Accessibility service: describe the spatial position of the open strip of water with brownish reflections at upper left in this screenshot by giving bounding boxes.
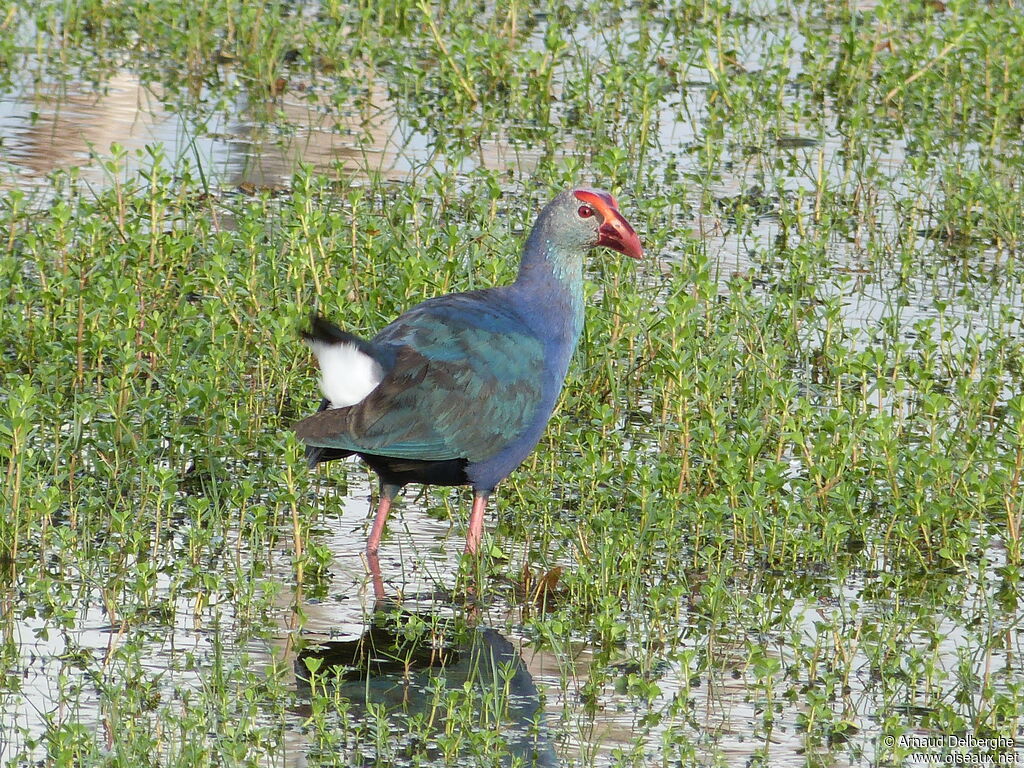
[0,71,430,195]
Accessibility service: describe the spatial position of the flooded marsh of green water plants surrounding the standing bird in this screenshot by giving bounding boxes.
[0,0,1024,766]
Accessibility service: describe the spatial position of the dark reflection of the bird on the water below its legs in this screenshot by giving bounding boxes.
[294,601,560,768]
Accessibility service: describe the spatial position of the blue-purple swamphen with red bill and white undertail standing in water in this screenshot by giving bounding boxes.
[295,188,643,588]
